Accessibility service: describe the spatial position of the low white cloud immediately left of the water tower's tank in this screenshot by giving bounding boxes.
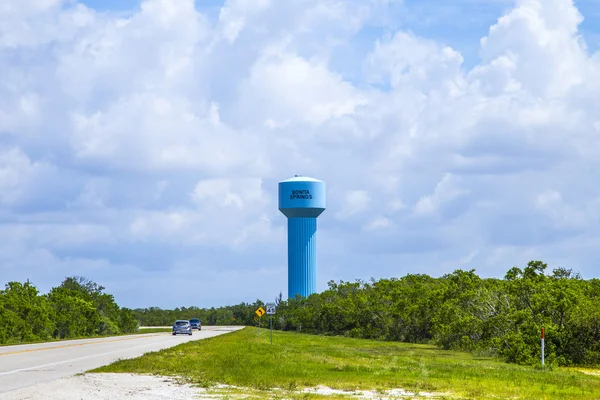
[128,178,284,251]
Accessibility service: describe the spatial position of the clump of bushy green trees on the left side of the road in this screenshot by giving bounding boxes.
[0,277,138,344]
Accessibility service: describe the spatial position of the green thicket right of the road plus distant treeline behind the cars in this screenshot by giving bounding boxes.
[134,261,600,366]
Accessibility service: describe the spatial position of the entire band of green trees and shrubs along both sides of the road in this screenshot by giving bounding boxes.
[5,261,600,367]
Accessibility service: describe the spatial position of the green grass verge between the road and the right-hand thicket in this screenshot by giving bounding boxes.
[91,328,600,399]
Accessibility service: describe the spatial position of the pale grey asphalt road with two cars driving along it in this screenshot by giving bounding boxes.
[0,326,242,398]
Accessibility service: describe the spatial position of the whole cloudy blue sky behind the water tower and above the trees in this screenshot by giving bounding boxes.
[0,0,600,308]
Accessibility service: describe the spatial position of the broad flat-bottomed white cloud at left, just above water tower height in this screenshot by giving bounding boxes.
[71,94,267,173]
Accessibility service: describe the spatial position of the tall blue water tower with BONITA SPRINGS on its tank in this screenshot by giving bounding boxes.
[279,175,325,298]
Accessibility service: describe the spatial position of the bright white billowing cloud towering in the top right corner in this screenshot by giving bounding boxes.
[481,0,587,97]
